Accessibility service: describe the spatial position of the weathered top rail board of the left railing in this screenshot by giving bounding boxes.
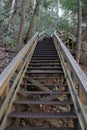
[0,33,38,96]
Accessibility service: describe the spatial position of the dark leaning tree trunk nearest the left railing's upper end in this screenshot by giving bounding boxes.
[24,0,40,43]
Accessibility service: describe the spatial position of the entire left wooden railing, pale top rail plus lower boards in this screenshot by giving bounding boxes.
[0,33,47,124]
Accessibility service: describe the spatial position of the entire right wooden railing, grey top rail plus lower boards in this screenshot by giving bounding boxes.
[53,33,87,130]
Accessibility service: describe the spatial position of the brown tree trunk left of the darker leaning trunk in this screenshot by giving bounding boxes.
[16,0,27,54]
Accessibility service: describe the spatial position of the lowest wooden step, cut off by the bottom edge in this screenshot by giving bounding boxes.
[5,126,79,130]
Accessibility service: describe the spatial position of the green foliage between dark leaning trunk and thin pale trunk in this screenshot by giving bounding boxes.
[37,0,56,34]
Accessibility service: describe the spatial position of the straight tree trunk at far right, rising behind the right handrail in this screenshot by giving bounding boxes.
[76,0,82,63]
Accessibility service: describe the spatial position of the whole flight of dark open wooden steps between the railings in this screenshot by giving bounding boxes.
[5,38,80,130]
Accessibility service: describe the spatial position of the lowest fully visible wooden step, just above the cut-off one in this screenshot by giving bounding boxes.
[8,112,77,119]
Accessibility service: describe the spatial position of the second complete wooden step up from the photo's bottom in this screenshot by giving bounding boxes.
[14,100,73,106]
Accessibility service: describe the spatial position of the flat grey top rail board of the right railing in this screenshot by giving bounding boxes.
[54,33,87,98]
